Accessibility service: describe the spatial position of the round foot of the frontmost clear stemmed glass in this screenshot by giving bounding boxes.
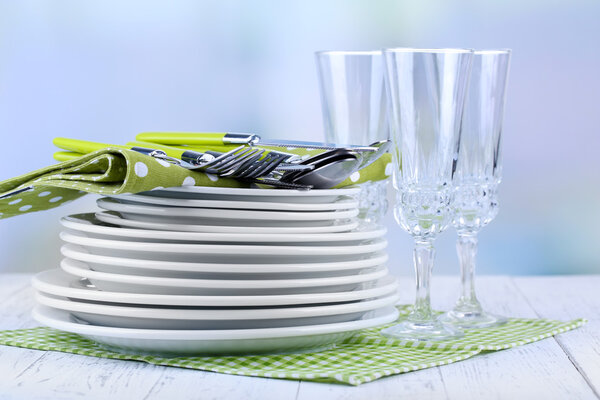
[381,320,463,341]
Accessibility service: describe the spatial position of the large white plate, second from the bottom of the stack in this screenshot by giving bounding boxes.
[36,292,398,329]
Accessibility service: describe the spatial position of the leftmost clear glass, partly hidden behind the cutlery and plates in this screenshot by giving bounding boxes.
[315,51,389,223]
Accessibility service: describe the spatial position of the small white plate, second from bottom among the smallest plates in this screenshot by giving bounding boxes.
[96,197,358,226]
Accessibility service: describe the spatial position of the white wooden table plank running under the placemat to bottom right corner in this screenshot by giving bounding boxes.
[439,277,596,400]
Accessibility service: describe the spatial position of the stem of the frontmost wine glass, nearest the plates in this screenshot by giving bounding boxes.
[408,239,435,321]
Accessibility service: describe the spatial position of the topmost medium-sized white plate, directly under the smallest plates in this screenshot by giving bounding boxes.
[60,213,386,246]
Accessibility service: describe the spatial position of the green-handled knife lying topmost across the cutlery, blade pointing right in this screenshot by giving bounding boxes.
[135,132,377,152]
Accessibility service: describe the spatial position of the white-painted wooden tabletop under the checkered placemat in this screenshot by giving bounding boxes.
[0,274,600,400]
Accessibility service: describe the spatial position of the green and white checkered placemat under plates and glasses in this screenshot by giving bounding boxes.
[0,306,587,385]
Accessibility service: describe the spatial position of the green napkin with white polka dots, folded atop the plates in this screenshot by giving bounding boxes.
[0,148,391,219]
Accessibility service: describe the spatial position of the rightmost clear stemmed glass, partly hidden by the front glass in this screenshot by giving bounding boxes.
[441,50,510,329]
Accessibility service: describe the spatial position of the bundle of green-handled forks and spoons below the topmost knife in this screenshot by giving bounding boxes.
[54,138,390,189]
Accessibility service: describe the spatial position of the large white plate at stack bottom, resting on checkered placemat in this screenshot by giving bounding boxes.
[33,306,398,355]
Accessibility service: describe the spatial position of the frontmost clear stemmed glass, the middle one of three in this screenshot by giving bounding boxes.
[382,49,472,340]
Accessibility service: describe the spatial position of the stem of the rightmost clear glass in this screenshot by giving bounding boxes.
[454,232,481,312]
